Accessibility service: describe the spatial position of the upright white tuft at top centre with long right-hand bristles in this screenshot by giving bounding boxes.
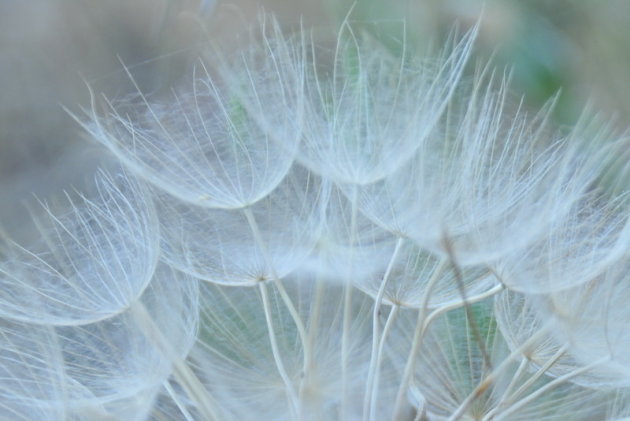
[298,21,477,185]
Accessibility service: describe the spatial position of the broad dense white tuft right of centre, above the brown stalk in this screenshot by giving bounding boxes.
[354,75,599,265]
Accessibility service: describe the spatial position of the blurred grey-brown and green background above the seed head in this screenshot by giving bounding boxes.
[0,0,630,226]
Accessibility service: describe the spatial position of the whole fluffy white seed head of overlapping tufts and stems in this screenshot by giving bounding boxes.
[0,13,630,421]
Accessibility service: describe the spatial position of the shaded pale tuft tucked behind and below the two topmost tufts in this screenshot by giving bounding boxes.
[156,166,329,286]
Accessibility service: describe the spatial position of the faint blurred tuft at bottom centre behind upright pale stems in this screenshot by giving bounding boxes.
[191,279,402,421]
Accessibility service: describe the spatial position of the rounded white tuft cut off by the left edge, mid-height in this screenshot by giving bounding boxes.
[0,172,159,325]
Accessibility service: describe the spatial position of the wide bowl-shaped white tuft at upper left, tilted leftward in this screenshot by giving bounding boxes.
[82,17,303,209]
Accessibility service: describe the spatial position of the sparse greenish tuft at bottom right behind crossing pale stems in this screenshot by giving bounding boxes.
[392,300,612,420]
